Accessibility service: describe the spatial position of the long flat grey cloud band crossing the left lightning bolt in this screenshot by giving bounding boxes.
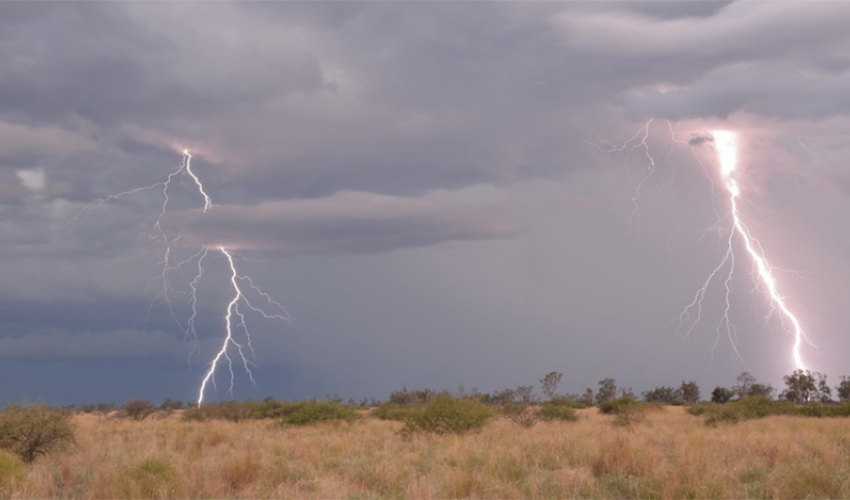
[181,192,520,255]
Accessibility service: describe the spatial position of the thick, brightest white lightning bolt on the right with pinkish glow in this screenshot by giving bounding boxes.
[679,130,811,370]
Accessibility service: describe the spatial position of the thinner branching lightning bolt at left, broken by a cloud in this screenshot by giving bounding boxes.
[71,150,289,406]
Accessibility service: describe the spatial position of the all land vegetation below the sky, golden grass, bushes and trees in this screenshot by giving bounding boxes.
[0,371,850,499]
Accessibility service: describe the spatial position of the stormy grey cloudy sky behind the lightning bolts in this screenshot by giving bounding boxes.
[0,0,850,404]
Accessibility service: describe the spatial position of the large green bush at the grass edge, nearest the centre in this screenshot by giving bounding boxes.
[402,395,493,434]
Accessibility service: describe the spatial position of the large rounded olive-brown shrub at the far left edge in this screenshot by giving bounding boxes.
[0,403,74,463]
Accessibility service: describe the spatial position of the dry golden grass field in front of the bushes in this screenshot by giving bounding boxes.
[0,407,850,499]
